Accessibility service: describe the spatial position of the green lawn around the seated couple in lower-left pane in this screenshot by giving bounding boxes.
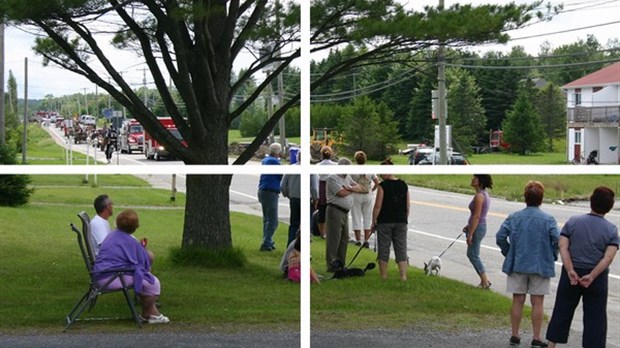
[0,175,300,333]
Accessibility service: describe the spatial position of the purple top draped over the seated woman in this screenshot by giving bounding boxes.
[94,230,155,293]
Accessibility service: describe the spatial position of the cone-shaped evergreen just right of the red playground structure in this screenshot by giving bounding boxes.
[502,79,544,155]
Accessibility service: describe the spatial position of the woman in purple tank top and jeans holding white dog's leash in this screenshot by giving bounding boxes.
[463,174,493,289]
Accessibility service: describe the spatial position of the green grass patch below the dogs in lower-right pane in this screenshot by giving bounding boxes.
[311,238,512,331]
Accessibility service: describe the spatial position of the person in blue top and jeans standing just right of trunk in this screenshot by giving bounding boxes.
[258,143,282,251]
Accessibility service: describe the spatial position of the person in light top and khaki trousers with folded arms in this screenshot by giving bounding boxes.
[325,157,360,272]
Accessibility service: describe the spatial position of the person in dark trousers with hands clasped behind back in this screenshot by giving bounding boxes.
[547,186,620,348]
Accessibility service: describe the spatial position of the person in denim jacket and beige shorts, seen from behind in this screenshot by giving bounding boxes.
[495,181,560,348]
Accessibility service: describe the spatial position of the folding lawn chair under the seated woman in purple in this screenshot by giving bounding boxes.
[64,212,142,331]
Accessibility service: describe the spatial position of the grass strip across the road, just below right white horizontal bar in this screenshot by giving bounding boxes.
[398,175,620,202]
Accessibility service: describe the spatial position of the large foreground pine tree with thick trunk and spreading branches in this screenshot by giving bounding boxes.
[0,0,552,250]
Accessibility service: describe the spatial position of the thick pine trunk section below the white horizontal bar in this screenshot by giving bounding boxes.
[182,175,232,250]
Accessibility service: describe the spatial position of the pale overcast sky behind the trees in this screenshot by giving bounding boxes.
[5,0,620,99]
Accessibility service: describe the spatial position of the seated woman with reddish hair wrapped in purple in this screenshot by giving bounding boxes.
[94,209,170,324]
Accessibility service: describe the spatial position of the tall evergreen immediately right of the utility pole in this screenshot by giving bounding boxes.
[446,69,487,153]
